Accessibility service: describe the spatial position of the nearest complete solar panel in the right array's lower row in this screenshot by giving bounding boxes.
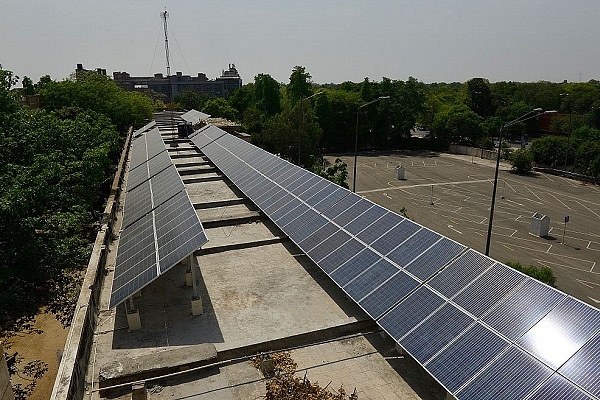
[425,324,509,393]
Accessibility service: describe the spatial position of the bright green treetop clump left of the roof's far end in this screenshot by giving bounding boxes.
[41,72,154,133]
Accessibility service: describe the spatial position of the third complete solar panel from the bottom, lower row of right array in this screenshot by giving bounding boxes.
[378,287,444,341]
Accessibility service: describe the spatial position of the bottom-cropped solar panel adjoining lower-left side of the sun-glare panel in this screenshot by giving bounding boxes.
[457,347,552,400]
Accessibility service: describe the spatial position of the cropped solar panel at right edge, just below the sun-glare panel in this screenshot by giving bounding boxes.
[558,332,600,397]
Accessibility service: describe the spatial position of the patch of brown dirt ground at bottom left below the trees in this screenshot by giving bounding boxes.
[5,312,69,400]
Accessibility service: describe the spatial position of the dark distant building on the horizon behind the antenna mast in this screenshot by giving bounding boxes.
[113,64,242,97]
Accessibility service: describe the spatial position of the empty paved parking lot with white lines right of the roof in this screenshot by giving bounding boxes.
[328,152,600,307]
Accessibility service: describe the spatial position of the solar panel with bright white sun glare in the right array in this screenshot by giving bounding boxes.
[517,297,600,369]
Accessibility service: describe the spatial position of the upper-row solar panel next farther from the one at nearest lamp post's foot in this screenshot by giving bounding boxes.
[404,238,466,281]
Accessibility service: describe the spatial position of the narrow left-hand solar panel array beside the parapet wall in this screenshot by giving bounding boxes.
[110,124,208,308]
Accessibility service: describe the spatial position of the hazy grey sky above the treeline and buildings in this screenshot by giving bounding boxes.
[0,0,600,83]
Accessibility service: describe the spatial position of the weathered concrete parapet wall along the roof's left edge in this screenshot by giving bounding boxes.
[50,129,132,400]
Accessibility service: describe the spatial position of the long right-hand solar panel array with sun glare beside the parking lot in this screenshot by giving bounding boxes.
[191,127,600,400]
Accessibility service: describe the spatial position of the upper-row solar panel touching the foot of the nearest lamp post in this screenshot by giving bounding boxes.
[427,250,494,298]
